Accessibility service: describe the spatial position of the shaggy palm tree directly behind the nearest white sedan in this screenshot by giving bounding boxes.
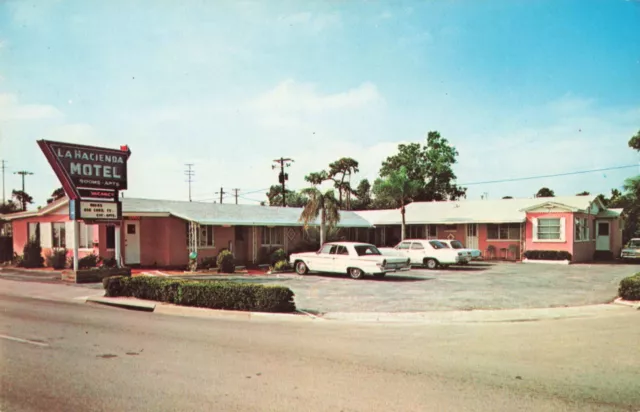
[299,187,340,247]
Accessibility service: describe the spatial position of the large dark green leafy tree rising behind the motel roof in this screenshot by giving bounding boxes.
[380,131,467,201]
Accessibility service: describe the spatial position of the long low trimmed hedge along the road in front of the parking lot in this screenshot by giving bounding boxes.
[102,276,296,313]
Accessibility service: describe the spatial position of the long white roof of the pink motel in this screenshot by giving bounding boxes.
[3,196,622,227]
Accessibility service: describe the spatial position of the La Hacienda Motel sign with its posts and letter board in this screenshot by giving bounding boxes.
[38,140,131,271]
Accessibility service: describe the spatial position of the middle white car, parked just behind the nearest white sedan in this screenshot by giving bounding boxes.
[380,239,470,269]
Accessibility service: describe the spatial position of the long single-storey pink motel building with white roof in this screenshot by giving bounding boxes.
[3,196,623,267]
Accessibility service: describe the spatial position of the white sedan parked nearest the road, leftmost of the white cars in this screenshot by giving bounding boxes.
[289,242,411,279]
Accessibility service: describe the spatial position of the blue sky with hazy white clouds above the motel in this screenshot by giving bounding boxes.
[0,0,640,208]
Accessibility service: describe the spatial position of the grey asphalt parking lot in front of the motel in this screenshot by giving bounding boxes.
[190,263,640,313]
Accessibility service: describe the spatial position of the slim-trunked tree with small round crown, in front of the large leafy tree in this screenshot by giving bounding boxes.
[373,166,422,240]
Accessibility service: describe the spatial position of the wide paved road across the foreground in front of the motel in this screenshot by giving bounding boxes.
[0,294,640,412]
